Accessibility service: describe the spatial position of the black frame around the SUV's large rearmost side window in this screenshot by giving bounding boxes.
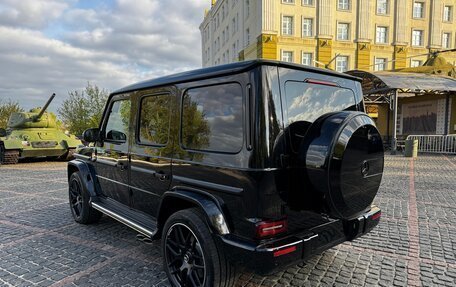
[178,81,247,155]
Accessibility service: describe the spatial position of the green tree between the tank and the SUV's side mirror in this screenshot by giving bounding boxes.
[58,83,109,135]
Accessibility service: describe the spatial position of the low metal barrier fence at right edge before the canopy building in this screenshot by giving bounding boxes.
[407,134,456,154]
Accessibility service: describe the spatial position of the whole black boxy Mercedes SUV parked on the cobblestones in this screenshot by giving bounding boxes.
[68,60,383,286]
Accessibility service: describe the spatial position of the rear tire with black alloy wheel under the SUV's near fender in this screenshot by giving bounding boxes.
[162,208,235,287]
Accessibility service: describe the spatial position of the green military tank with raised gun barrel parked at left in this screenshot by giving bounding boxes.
[0,94,81,164]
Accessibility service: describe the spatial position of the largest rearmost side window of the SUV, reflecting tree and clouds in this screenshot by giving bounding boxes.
[181,83,243,153]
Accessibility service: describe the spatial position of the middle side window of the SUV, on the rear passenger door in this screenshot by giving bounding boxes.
[139,94,171,146]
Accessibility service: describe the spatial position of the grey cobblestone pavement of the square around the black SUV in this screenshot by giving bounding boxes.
[0,156,456,287]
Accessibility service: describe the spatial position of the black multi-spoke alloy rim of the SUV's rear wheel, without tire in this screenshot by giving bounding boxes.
[165,223,206,287]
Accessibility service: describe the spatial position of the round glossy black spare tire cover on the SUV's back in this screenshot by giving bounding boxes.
[299,111,384,219]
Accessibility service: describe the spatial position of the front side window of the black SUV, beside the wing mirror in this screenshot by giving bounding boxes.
[105,100,131,143]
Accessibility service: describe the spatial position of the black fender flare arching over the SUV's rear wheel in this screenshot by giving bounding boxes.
[157,188,230,235]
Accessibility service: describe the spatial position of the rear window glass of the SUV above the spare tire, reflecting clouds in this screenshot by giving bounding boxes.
[285,81,356,124]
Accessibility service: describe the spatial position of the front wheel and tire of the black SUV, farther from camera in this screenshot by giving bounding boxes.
[68,172,103,224]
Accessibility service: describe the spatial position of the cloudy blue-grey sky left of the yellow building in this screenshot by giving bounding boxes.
[0,0,210,112]
